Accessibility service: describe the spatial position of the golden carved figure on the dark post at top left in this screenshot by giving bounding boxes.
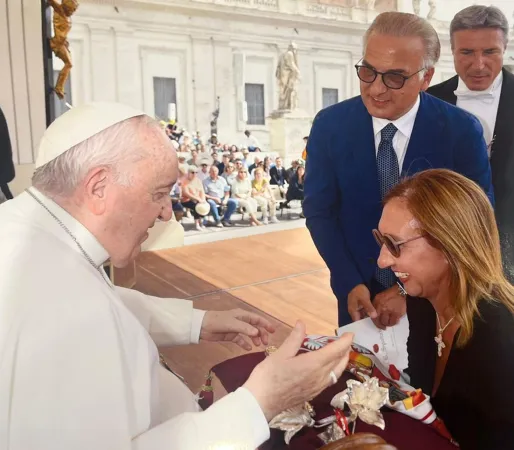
[48,0,79,99]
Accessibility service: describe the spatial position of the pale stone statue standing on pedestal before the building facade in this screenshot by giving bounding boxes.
[275,42,300,111]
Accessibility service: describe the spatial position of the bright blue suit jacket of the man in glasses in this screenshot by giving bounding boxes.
[303,92,494,325]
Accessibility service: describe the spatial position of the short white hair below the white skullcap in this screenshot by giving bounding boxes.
[32,116,160,198]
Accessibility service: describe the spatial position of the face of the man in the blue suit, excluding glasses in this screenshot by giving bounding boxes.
[360,34,434,120]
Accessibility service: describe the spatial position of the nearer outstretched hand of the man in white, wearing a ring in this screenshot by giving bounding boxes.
[244,322,353,421]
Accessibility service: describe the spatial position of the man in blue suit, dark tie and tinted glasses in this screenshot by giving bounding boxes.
[303,12,493,326]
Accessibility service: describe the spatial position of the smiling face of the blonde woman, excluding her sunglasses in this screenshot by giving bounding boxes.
[378,198,450,299]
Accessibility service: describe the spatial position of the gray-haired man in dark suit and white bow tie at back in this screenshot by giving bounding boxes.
[428,5,514,282]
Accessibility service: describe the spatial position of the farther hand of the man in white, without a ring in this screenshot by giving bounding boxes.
[200,309,275,351]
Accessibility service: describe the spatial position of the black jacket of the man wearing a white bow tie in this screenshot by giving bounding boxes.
[428,69,514,282]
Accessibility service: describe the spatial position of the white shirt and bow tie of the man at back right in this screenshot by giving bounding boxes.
[454,71,503,152]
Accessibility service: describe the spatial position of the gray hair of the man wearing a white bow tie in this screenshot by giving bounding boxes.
[450,5,509,49]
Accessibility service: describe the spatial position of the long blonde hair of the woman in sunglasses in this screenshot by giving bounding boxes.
[384,169,514,347]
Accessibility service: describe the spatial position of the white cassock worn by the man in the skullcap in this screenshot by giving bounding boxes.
[0,188,269,450]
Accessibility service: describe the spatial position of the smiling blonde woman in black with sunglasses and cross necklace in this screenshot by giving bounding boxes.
[373,169,514,450]
